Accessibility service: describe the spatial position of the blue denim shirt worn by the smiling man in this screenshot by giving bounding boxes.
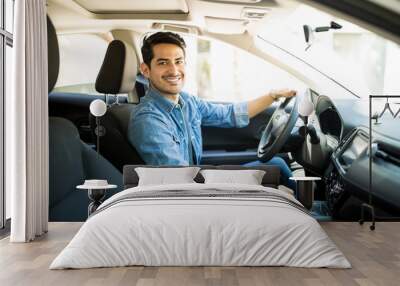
[128,88,249,165]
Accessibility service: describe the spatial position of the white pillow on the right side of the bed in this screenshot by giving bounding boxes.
[200,170,265,185]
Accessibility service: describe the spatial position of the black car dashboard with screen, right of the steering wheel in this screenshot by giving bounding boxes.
[292,91,400,220]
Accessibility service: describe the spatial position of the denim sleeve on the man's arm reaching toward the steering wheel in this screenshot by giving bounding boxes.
[196,98,249,128]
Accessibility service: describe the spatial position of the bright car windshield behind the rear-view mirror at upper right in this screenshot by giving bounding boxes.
[258,4,400,97]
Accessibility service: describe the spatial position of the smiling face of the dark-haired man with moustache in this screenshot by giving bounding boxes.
[141,44,185,95]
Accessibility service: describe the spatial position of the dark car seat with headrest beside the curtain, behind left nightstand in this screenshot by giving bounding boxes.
[47,17,122,221]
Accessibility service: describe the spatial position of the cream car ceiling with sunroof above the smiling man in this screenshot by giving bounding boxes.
[47,0,292,34]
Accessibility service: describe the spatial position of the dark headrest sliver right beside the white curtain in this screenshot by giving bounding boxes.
[47,16,60,92]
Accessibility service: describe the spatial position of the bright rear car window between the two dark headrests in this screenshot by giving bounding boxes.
[54,34,108,94]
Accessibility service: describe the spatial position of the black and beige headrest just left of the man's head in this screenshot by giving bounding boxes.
[96,40,138,94]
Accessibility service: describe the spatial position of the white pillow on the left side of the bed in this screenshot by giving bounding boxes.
[135,167,200,186]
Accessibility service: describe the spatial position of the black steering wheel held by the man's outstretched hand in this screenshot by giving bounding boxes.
[257,96,300,162]
